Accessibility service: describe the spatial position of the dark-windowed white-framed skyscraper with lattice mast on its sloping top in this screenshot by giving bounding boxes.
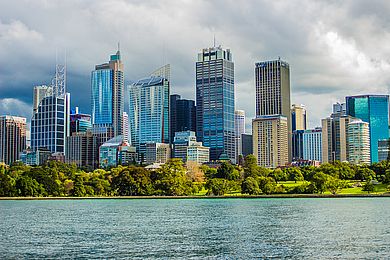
[31,65,70,154]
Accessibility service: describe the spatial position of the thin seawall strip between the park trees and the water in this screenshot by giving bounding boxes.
[0,193,390,201]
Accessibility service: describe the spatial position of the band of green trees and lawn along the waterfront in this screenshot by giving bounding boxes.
[0,155,390,197]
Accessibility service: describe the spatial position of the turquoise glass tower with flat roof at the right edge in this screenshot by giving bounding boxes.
[346,95,389,163]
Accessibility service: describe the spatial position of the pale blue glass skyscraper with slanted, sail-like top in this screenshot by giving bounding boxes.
[129,76,170,153]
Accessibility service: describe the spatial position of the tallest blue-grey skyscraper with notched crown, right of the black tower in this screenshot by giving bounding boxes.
[196,46,236,163]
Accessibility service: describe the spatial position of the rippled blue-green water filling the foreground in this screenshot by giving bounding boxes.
[0,198,390,259]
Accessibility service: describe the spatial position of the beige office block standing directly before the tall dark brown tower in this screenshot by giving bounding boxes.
[252,115,289,168]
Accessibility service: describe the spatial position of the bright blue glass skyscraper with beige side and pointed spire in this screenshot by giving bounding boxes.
[91,50,124,136]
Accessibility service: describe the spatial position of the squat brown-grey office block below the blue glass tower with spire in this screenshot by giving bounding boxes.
[65,130,99,169]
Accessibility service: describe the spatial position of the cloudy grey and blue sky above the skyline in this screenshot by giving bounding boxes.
[0,0,390,132]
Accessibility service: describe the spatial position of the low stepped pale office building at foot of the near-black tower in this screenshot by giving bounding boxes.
[173,131,210,164]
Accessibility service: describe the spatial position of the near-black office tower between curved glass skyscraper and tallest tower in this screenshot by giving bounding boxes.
[170,94,196,143]
